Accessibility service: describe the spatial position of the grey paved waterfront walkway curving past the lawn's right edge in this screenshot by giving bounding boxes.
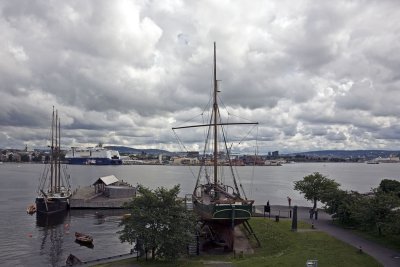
[258,205,400,267]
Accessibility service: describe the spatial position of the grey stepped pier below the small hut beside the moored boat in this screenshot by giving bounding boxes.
[70,186,133,209]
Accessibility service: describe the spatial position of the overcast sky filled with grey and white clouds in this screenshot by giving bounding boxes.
[0,0,400,152]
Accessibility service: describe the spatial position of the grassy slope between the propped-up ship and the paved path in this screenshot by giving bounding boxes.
[237,218,381,266]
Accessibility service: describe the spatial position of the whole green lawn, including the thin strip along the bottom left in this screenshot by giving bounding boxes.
[94,218,381,267]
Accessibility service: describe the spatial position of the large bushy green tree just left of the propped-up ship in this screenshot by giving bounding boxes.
[118,185,196,259]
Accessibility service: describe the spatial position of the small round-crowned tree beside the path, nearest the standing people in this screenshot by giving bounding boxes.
[294,172,340,213]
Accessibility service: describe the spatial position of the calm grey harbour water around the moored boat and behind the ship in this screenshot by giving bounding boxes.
[0,163,400,266]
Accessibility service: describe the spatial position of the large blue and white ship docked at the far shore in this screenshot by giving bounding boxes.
[65,147,122,165]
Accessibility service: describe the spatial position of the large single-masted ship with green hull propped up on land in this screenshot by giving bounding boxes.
[172,43,258,250]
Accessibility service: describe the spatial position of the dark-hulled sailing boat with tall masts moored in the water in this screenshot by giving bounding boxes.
[35,107,71,214]
